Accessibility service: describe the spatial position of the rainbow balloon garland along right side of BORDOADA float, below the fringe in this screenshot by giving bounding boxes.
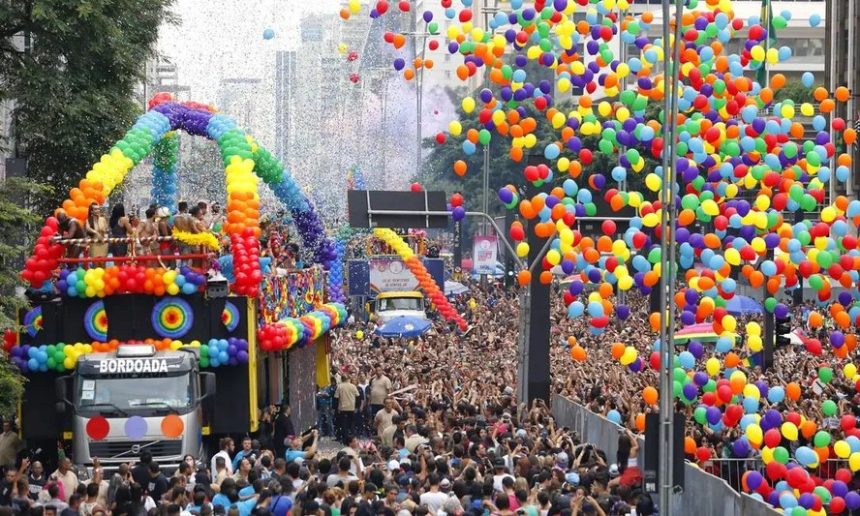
[257,303,348,352]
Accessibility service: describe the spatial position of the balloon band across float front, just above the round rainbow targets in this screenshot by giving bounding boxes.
[56,264,206,298]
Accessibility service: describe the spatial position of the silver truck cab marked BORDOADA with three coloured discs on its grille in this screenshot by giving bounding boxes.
[56,345,215,469]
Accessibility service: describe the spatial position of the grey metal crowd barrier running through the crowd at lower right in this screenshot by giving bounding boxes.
[552,396,780,516]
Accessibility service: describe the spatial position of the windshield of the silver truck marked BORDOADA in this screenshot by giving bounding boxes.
[75,373,194,416]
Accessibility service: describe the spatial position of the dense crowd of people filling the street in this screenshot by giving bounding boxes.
[0,232,860,516]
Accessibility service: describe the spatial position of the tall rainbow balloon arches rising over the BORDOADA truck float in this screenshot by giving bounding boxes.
[21,94,343,300]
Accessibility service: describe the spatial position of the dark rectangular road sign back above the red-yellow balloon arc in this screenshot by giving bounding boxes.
[347,190,450,229]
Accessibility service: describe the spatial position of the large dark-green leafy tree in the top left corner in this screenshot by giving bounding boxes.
[0,0,172,212]
